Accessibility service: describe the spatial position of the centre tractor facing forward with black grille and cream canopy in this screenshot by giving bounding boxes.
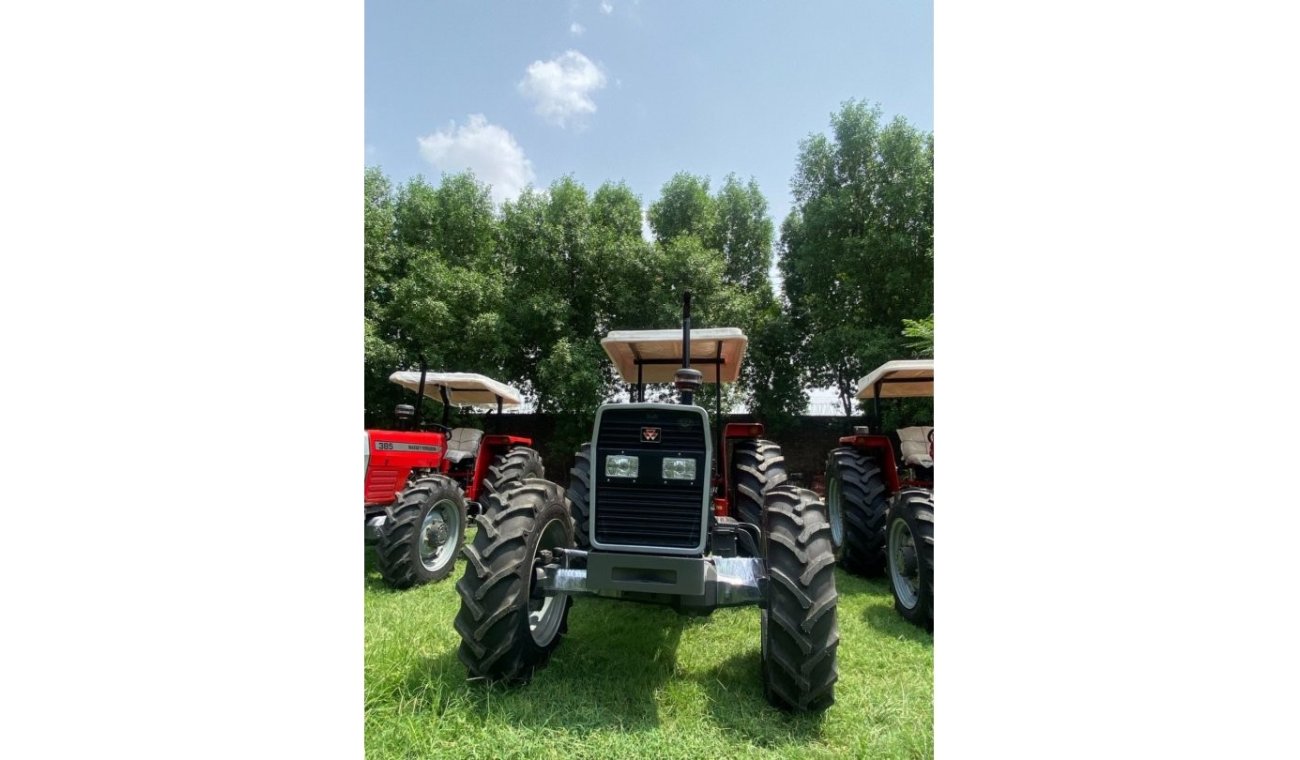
[455,292,840,712]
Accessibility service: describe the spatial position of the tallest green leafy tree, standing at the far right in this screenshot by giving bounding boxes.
[780,101,935,414]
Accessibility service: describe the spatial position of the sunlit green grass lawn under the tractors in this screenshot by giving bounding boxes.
[365,532,933,760]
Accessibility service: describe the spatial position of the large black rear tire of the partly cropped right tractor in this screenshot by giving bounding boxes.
[826,446,889,577]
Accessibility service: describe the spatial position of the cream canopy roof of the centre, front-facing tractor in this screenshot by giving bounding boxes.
[601,327,749,383]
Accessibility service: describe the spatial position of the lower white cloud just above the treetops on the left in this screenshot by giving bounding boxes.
[419,113,536,203]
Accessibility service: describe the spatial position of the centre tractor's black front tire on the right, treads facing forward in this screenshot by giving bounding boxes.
[759,486,840,712]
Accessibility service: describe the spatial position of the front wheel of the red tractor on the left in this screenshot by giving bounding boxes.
[376,475,468,589]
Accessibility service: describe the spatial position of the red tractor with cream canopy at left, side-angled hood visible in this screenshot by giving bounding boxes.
[365,369,545,589]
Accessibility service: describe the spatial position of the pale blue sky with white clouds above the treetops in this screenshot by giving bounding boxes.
[365,0,933,236]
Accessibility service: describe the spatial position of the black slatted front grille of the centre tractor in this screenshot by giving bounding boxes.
[592,404,712,551]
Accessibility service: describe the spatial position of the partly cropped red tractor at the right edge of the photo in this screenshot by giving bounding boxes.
[826,359,935,627]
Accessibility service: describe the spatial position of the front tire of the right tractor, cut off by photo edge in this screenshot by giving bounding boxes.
[888,488,935,629]
